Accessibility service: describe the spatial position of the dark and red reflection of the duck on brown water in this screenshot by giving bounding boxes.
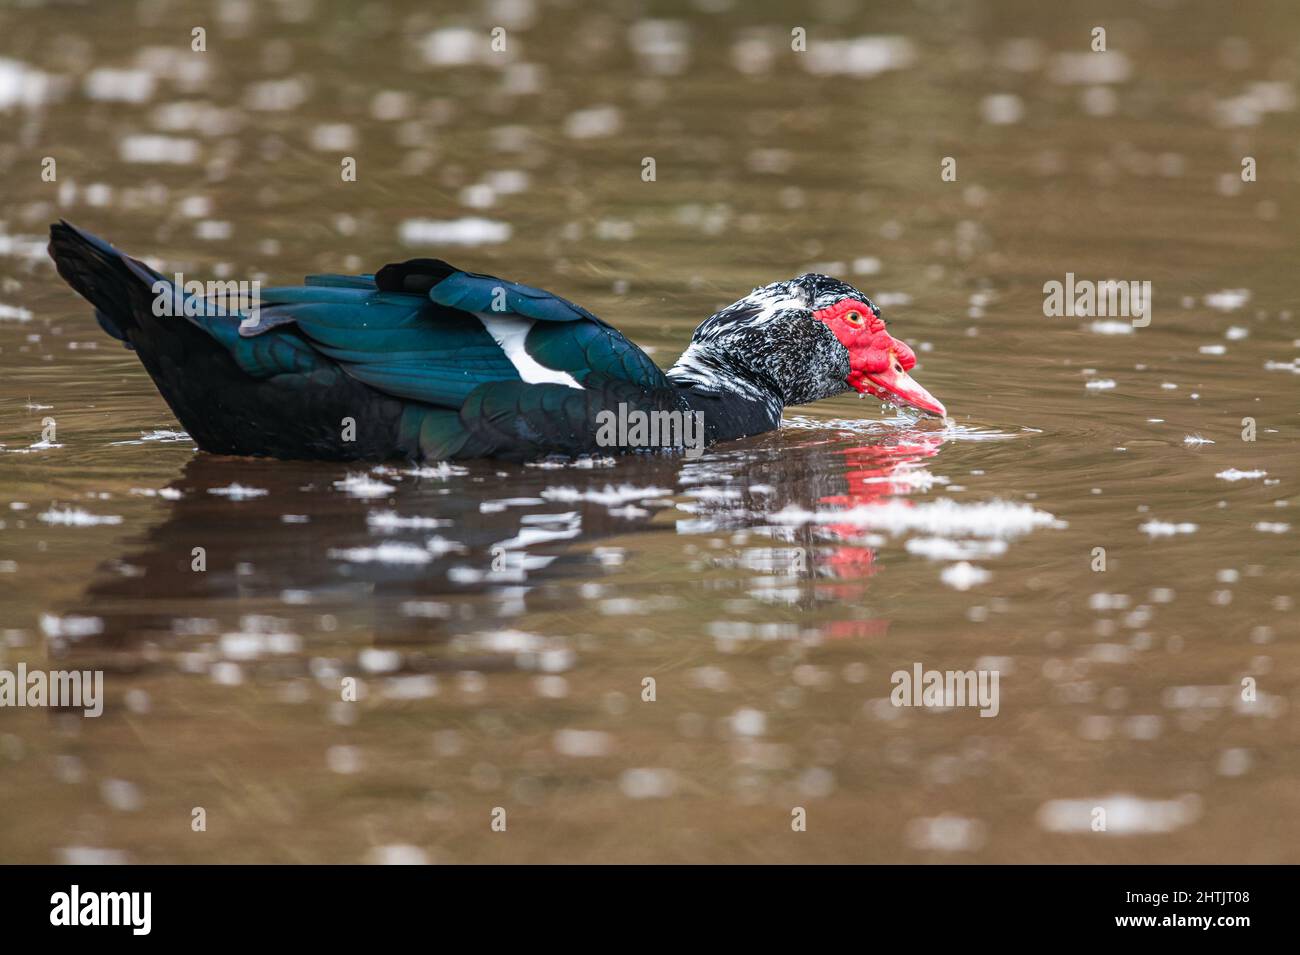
[58,429,944,657]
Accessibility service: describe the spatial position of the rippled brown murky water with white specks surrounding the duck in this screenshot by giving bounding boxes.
[0,0,1300,863]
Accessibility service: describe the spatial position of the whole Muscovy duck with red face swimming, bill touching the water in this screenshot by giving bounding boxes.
[49,222,946,461]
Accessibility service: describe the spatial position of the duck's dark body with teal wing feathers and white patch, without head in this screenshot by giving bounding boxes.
[51,223,683,460]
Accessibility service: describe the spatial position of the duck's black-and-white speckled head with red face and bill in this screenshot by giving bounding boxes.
[670,273,948,417]
